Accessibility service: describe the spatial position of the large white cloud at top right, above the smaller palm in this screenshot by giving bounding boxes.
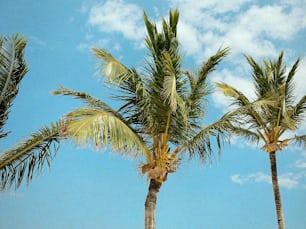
[170,0,306,59]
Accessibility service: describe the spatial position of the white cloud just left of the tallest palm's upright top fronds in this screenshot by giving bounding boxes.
[88,0,145,41]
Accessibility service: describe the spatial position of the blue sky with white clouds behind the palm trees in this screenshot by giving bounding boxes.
[0,0,306,229]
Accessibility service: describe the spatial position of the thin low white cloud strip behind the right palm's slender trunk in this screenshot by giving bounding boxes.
[230,172,306,189]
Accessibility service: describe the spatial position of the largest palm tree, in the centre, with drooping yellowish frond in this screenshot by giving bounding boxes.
[0,10,230,229]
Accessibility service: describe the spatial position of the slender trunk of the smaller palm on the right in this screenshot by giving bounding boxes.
[269,152,285,229]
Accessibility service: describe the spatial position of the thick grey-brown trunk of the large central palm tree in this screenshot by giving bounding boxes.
[145,179,162,229]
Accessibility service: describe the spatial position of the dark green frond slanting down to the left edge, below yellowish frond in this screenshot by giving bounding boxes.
[0,121,64,190]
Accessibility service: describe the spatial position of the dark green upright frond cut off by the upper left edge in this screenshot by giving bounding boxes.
[0,34,28,137]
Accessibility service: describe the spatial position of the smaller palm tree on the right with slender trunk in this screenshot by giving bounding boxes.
[216,52,306,229]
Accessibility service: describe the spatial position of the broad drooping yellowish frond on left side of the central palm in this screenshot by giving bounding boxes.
[63,108,151,161]
